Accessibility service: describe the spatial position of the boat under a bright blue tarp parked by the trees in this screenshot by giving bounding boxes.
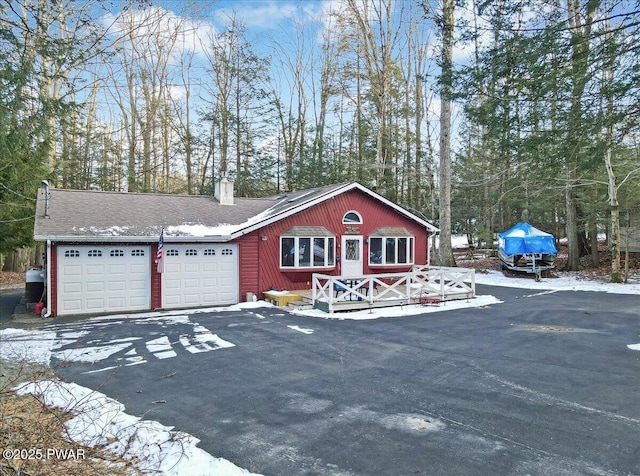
[498,222,558,280]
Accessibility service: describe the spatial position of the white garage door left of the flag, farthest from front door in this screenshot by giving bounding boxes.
[57,245,151,315]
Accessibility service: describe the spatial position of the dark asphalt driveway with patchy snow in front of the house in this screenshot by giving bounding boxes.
[26,286,640,475]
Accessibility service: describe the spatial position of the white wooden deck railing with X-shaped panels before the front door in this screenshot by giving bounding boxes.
[312,266,476,312]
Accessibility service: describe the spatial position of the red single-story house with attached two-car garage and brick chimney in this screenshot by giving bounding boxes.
[34,179,437,316]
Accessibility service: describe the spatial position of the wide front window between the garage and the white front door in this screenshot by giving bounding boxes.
[280,226,336,269]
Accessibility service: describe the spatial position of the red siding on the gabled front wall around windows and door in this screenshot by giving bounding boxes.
[230,190,428,300]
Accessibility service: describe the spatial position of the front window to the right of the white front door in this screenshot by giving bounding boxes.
[369,227,415,266]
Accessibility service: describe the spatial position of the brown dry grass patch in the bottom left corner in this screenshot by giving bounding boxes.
[0,362,139,476]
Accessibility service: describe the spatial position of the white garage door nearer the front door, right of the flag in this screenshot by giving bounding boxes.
[162,243,238,308]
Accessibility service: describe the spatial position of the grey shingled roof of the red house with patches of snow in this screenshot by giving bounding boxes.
[34,182,437,242]
